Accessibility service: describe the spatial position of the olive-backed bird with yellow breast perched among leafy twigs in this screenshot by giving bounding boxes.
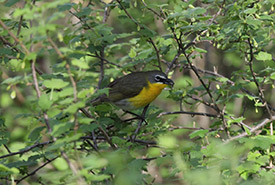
[91,70,174,111]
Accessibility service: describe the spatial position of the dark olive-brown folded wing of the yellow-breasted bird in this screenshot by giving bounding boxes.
[108,74,147,102]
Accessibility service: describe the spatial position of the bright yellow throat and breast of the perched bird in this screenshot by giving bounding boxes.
[128,82,167,108]
